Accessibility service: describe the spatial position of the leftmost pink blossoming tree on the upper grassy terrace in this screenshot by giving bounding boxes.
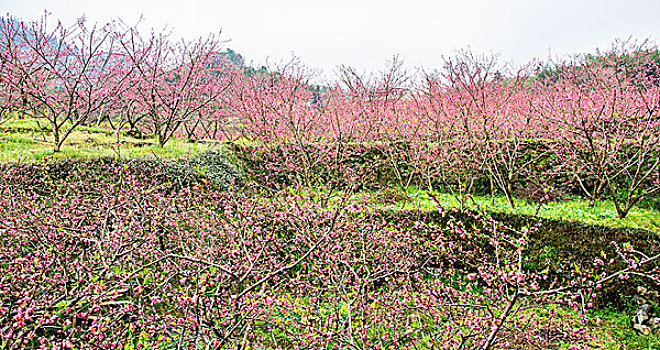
[2,16,130,152]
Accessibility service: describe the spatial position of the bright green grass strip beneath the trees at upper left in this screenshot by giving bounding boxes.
[0,119,211,162]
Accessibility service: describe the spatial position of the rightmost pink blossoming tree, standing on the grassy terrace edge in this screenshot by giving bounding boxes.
[539,44,660,218]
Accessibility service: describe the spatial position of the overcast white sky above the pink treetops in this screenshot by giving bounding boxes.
[0,0,660,78]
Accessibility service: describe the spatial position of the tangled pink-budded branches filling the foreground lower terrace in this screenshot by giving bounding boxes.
[0,163,658,349]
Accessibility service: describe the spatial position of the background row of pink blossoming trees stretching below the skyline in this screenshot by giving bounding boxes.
[0,17,660,218]
